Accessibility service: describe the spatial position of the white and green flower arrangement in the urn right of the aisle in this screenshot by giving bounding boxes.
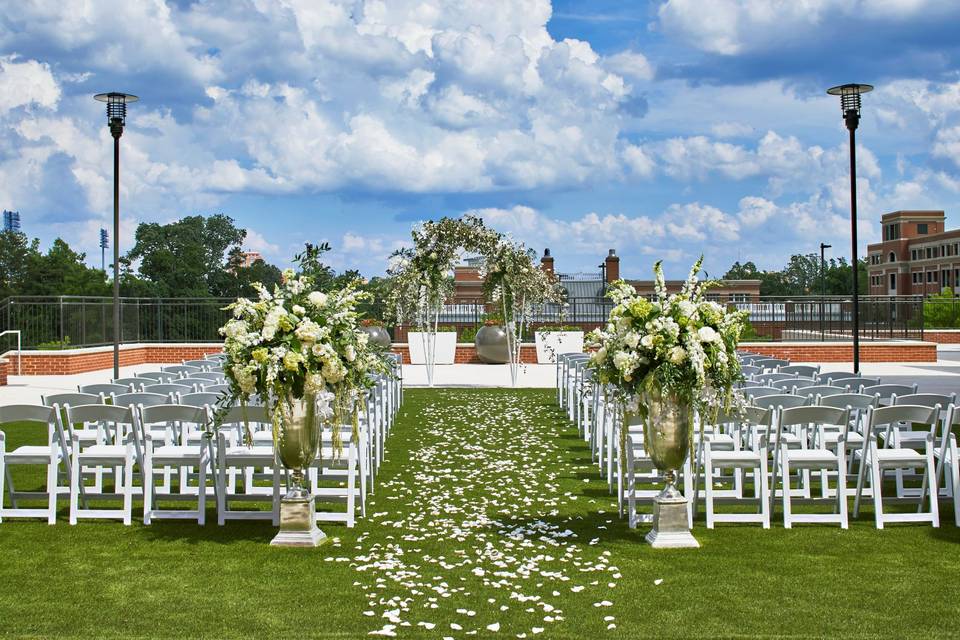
[586,257,747,411]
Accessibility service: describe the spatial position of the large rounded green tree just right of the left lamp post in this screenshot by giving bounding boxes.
[127,214,247,297]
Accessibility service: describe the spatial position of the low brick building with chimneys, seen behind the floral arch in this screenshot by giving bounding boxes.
[453,249,760,303]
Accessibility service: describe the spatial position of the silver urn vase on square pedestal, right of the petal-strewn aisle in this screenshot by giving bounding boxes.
[639,386,700,549]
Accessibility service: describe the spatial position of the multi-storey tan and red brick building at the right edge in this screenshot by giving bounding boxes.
[867,211,960,295]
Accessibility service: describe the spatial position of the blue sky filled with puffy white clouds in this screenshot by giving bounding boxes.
[0,0,960,277]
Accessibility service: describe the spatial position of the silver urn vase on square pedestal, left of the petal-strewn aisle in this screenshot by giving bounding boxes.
[270,394,327,547]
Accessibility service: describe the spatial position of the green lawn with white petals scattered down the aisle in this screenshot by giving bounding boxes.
[0,389,960,638]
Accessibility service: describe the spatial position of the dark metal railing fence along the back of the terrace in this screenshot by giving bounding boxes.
[0,296,928,350]
